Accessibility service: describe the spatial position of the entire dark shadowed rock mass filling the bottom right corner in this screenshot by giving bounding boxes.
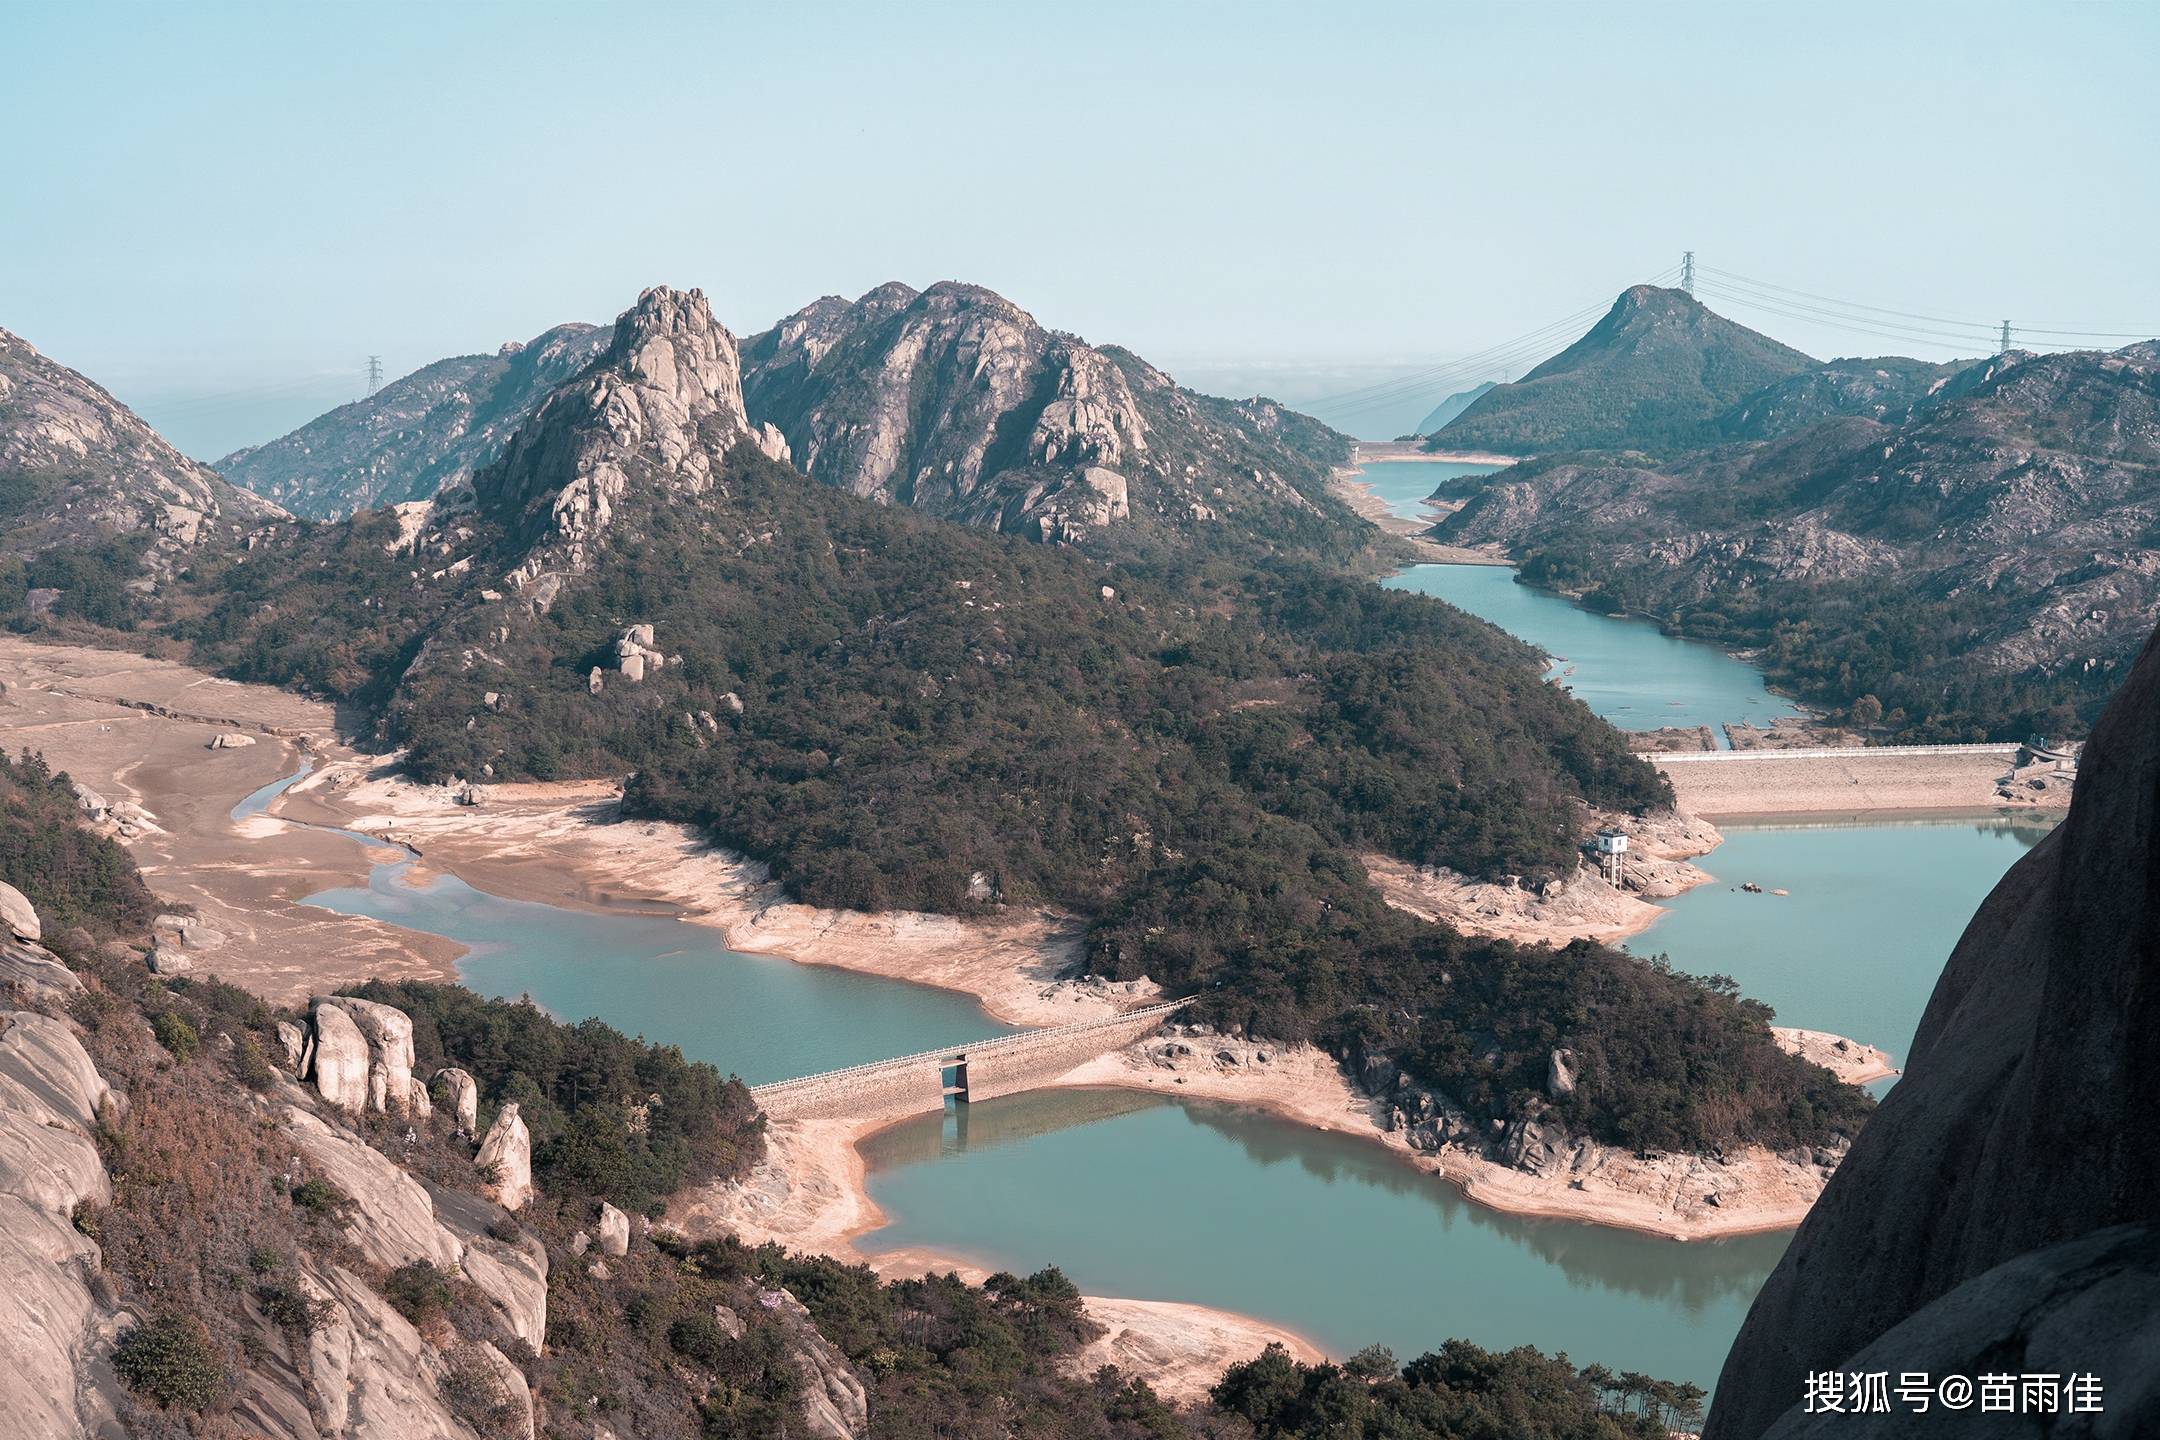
[1704,621,2160,1440]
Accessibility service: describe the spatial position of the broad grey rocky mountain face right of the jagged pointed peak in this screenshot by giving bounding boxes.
[743,281,1363,548]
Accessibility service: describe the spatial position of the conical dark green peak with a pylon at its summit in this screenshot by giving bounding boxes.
[1426,285,1817,456]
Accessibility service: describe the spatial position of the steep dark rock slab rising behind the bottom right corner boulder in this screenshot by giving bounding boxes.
[1704,626,2160,1440]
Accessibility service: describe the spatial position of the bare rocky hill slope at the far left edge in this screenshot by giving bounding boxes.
[0,330,281,583]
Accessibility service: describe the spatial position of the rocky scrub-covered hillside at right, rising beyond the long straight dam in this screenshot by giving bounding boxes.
[1439,343,2160,741]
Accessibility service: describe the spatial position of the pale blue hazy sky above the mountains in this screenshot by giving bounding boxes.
[0,0,2160,458]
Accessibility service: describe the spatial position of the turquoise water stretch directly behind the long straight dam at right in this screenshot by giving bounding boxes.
[1382,566,1799,747]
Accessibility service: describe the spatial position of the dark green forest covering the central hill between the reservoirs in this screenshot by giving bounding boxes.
[0,433,1866,1164]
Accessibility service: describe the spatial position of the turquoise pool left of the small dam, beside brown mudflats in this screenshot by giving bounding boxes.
[309,864,1011,1084]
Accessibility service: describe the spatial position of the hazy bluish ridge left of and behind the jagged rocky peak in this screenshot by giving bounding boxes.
[216,324,609,520]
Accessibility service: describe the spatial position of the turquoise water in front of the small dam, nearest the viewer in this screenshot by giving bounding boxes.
[862,1090,1786,1386]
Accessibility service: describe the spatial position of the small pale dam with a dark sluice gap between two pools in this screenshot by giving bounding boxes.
[750,1000,1192,1120]
